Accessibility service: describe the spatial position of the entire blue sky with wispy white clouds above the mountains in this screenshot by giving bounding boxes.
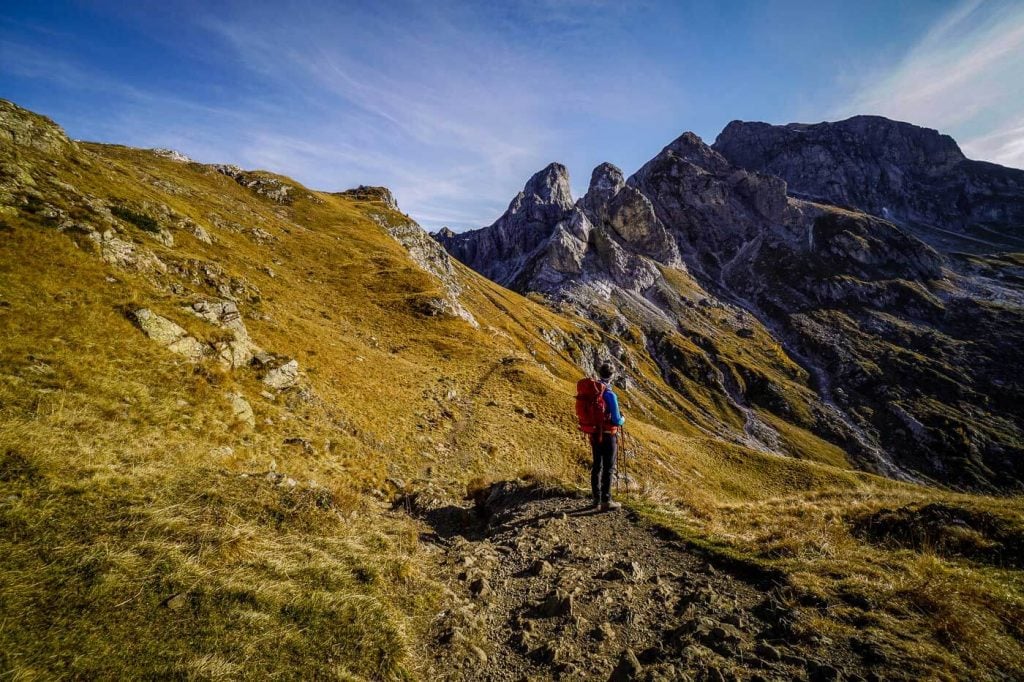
[6,0,1024,229]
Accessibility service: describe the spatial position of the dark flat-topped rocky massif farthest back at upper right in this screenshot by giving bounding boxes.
[713,116,1024,253]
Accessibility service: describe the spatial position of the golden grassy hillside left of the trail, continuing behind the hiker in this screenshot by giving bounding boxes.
[0,102,1020,678]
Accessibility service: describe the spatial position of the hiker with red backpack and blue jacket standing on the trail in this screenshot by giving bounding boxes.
[577,364,626,511]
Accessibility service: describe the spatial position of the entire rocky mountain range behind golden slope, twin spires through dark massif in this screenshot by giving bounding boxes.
[434,117,1024,489]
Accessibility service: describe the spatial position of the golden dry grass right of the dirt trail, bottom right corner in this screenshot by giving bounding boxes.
[640,486,1024,680]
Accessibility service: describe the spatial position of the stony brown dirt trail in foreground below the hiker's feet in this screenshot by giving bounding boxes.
[409,481,876,681]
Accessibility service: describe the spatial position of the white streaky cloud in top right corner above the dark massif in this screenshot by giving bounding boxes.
[837,0,1024,168]
